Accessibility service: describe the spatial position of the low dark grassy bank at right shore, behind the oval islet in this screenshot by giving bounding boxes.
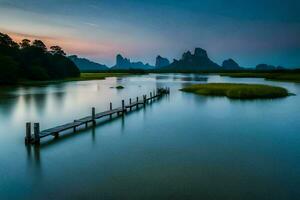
[220,72,300,83]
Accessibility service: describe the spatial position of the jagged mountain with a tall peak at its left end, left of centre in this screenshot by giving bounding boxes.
[111,54,154,70]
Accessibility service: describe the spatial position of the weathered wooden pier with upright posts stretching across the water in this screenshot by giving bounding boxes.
[25,88,170,144]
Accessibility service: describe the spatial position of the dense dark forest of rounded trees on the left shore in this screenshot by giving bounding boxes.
[0,33,80,84]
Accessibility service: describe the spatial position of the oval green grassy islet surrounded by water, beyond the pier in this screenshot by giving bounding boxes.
[181,83,289,99]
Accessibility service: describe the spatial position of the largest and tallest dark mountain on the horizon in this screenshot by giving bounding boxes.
[163,48,221,71]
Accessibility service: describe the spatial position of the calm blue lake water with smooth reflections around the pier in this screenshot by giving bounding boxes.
[0,74,300,200]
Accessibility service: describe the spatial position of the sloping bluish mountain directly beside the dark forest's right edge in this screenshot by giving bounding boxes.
[69,55,109,71]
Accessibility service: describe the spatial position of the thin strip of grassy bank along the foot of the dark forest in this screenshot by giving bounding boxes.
[17,73,131,85]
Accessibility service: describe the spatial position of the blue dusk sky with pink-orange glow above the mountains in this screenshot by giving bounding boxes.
[0,0,300,67]
